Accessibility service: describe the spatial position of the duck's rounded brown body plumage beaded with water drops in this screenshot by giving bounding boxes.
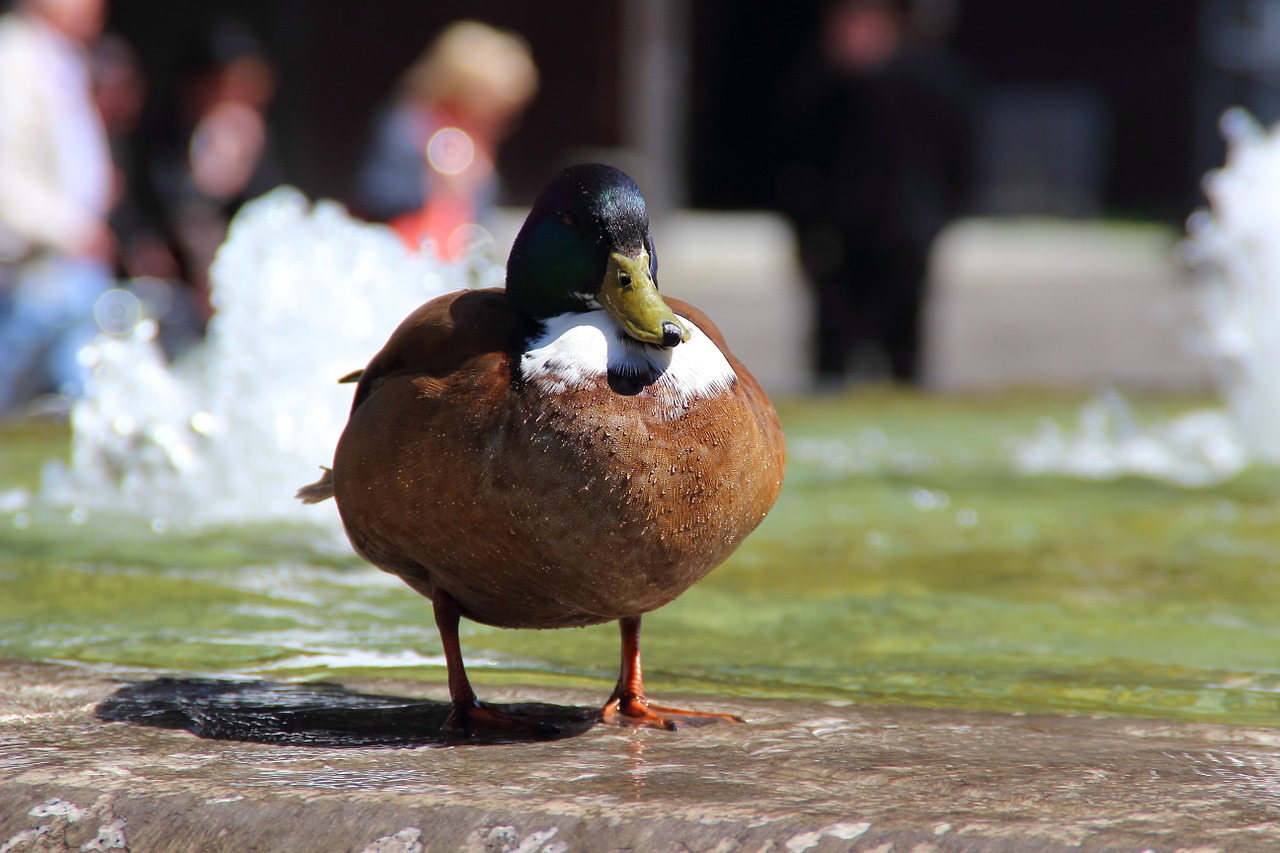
[333,285,783,628]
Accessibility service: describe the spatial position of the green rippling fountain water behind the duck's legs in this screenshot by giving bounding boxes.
[0,393,1280,725]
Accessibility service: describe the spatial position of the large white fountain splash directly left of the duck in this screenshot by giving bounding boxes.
[40,187,500,532]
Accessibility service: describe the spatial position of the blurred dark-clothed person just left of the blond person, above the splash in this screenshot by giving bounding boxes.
[155,19,283,318]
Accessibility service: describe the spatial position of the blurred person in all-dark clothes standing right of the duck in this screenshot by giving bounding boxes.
[777,0,969,388]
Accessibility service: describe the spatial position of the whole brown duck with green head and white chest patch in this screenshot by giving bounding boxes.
[300,164,785,731]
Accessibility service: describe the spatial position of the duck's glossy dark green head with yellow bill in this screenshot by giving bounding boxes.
[507,163,689,347]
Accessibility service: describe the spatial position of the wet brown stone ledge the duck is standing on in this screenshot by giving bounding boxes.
[0,663,1280,853]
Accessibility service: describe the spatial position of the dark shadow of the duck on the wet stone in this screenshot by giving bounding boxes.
[93,678,599,748]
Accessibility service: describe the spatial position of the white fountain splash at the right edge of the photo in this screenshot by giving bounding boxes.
[1015,109,1280,485]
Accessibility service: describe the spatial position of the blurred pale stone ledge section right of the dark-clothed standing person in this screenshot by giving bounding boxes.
[925,219,1212,393]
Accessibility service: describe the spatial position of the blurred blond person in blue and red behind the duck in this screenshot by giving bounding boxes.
[356,20,538,259]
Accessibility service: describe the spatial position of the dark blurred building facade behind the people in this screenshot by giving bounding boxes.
[110,0,1280,222]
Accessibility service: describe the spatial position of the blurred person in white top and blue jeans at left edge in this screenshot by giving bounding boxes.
[0,0,115,411]
